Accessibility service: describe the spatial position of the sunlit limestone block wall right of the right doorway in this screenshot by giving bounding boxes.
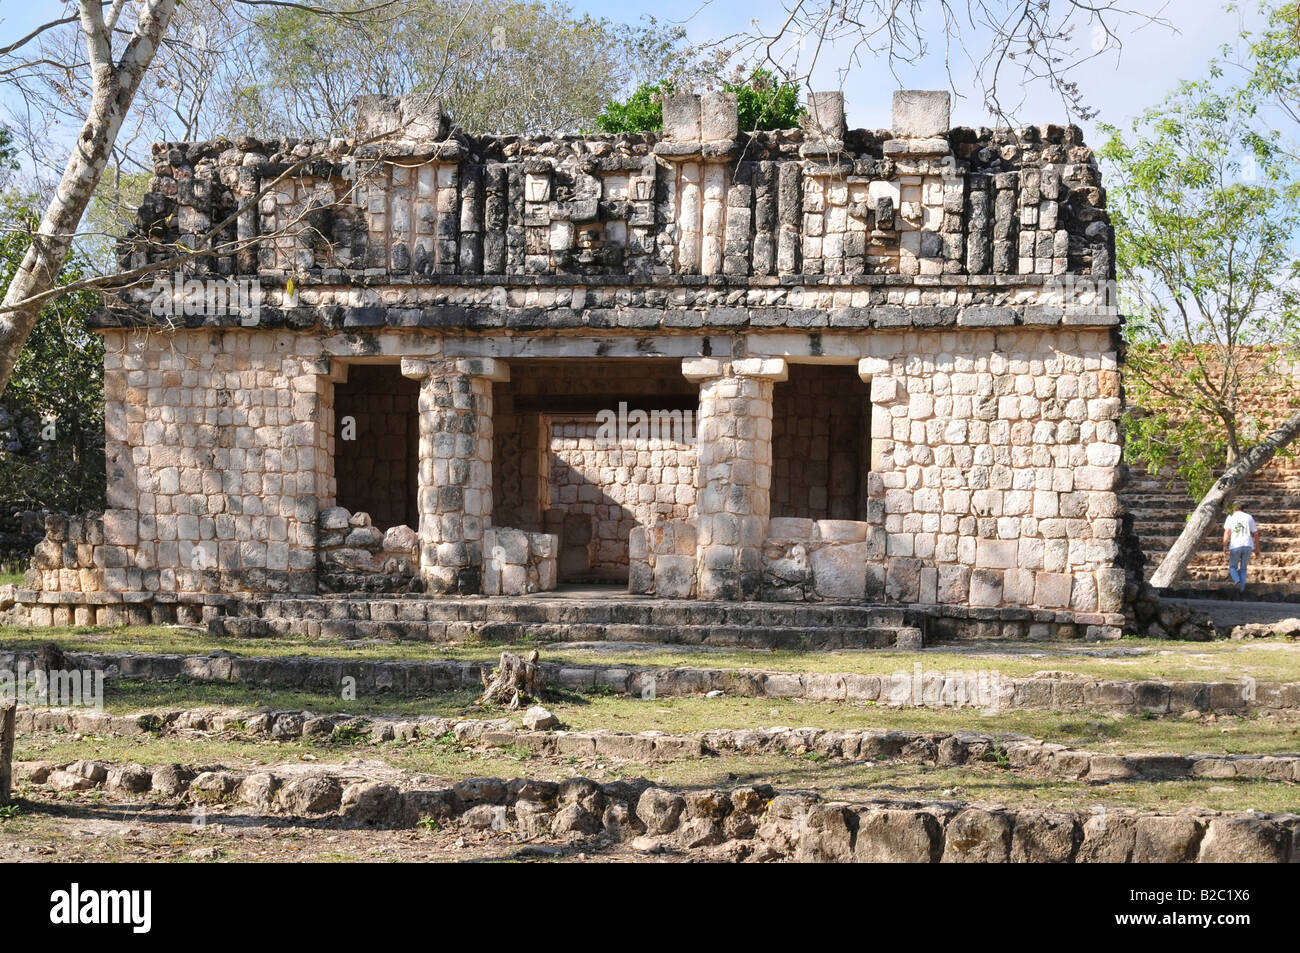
[859,329,1125,614]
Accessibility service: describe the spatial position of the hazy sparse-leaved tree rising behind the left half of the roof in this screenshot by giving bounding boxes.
[218,0,689,135]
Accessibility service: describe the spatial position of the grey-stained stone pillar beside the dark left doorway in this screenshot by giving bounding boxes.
[402,358,510,594]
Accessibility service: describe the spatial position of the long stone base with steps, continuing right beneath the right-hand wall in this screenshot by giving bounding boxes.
[208,586,1122,650]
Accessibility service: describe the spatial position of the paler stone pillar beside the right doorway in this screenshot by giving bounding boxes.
[681,358,787,601]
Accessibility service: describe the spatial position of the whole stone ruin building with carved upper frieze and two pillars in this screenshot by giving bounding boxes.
[0,91,1126,638]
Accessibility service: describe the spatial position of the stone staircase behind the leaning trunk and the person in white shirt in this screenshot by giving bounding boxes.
[1121,460,1300,598]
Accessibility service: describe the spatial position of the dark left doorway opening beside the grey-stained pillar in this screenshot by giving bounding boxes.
[334,364,420,529]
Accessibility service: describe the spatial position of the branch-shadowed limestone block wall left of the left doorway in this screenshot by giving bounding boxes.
[101,330,334,593]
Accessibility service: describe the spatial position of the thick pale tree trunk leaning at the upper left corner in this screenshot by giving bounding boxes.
[0,0,176,394]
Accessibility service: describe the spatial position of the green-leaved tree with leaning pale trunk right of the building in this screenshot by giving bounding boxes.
[1101,73,1300,585]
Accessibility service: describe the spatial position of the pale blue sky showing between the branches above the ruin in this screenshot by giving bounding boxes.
[0,0,1260,142]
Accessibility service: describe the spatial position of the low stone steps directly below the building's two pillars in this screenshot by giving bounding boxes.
[208,595,927,650]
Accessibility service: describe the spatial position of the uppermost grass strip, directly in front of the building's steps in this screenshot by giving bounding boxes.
[0,625,1300,681]
